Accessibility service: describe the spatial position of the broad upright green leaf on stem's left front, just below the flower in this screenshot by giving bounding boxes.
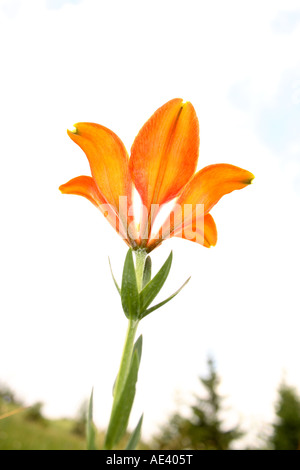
[121,249,140,320]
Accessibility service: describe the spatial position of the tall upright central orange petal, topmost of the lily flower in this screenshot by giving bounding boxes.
[129,98,199,212]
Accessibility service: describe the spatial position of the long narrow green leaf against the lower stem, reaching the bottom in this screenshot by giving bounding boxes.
[104,349,140,449]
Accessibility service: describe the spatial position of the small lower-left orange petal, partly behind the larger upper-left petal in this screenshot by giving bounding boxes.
[59,176,127,242]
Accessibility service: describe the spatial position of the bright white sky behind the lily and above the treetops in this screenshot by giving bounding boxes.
[0,0,300,448]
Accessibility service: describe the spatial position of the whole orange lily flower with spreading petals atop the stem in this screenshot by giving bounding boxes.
[59,98,254,253]
